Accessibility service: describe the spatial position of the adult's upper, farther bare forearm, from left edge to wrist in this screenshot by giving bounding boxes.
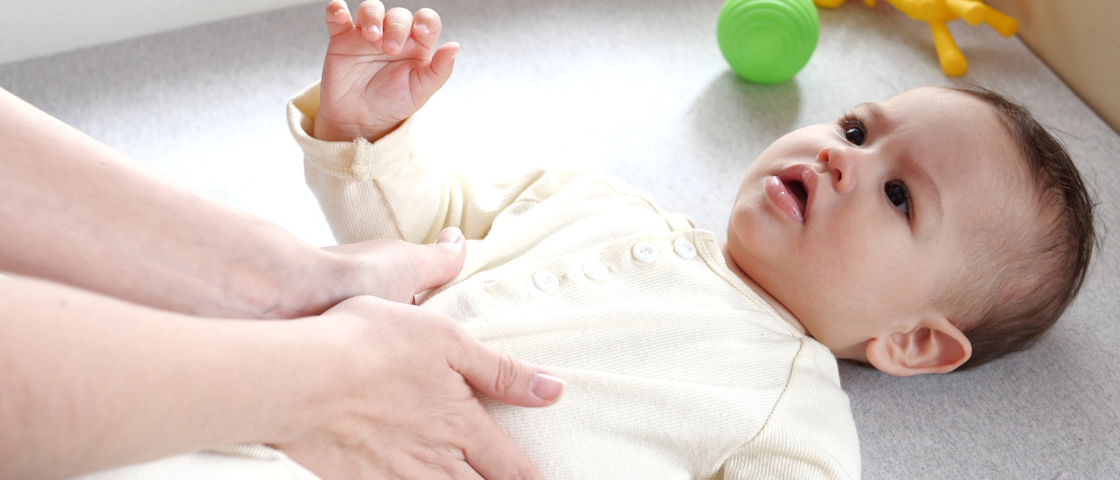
[0,90,345,318]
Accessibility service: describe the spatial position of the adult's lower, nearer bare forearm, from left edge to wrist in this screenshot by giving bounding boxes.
[0,273,343,479]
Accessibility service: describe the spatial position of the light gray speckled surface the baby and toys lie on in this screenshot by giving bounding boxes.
[0,0,1120,479]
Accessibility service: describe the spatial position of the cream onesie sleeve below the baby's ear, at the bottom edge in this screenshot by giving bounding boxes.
[722,339,860,480]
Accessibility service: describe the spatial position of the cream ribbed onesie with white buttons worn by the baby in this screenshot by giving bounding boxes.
[78,85,860,480]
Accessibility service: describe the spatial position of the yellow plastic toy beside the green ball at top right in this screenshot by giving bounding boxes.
[813,0,1019,77]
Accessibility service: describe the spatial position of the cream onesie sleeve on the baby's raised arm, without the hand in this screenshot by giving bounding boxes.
[288,84,544,244]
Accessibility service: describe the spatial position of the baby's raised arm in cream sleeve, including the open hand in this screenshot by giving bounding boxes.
[288,0,564,243]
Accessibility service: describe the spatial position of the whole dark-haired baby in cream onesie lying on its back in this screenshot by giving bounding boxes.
[282,1,1094,479]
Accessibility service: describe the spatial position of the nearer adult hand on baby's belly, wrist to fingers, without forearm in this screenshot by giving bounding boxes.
[276,297,563,480]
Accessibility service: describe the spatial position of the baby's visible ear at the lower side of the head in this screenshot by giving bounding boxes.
[867,317,972,377]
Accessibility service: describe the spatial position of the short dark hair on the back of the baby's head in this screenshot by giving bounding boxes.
[942,87,1098,369]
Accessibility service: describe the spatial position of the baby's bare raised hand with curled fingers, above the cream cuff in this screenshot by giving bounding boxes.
[312,0,459,142]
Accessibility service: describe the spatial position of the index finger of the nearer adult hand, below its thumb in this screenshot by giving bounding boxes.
[463,411,544,480]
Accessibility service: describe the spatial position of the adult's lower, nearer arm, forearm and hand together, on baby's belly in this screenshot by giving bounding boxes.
[0,229,563,480]
